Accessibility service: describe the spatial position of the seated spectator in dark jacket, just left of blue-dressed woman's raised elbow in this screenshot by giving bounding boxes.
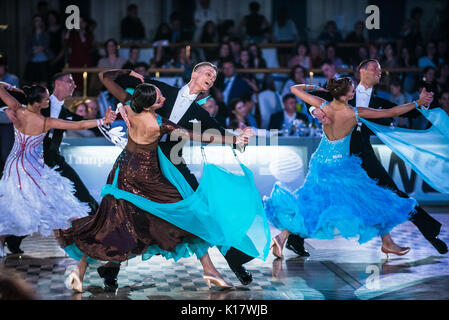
[268,93,309,130]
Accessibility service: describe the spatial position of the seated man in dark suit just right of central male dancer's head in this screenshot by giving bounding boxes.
[217,59,253,106]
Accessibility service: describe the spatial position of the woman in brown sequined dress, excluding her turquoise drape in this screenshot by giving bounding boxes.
[55,72,249,292]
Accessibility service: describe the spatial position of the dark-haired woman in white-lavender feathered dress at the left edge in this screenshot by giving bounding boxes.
[0,82,115,256]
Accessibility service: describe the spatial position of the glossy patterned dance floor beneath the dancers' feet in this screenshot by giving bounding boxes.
[0,207,449,300]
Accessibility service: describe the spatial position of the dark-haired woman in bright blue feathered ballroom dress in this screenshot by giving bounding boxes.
[264,78,433,258]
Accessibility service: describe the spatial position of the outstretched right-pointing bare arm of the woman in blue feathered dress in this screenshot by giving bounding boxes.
[357,89,433,119]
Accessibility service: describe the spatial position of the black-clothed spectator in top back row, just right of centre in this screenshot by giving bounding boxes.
[239,1,270,42]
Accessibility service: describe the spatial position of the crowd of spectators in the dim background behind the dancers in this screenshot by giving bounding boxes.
[0,0,449,136]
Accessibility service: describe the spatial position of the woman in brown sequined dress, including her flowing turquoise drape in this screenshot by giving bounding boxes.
[55,73,269,292]
